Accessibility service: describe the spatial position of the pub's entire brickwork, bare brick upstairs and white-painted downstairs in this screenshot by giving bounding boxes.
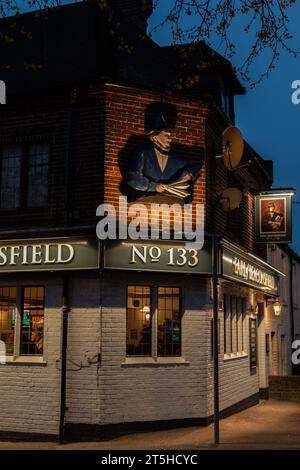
[0,81,274,434]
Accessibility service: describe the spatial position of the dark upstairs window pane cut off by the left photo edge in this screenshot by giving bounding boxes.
[1,145,22,209]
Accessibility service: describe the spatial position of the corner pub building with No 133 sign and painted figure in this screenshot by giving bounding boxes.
[0,0,280,439]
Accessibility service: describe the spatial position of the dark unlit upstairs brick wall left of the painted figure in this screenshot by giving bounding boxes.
[0,89,104,231]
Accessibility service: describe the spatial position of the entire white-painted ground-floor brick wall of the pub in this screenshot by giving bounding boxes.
[0,272,264,434]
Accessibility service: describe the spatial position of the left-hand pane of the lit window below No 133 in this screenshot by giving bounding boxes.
[126,286,151,356]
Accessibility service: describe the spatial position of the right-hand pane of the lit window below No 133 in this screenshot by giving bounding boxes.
[157,287,181,356]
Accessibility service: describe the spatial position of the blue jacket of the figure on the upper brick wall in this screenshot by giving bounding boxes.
[127,142,200,193]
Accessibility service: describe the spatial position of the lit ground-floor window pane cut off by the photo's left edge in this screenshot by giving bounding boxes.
[0,287,16,354]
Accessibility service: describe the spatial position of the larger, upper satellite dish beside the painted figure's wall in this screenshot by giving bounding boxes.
[222,126,244,170]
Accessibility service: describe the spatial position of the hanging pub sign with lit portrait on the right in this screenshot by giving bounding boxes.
[255,190,294,243]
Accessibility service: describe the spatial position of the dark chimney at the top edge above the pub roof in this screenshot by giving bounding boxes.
[110,0,153,33]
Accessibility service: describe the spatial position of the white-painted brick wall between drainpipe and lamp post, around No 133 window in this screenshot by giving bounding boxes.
[63,273,211,424]
